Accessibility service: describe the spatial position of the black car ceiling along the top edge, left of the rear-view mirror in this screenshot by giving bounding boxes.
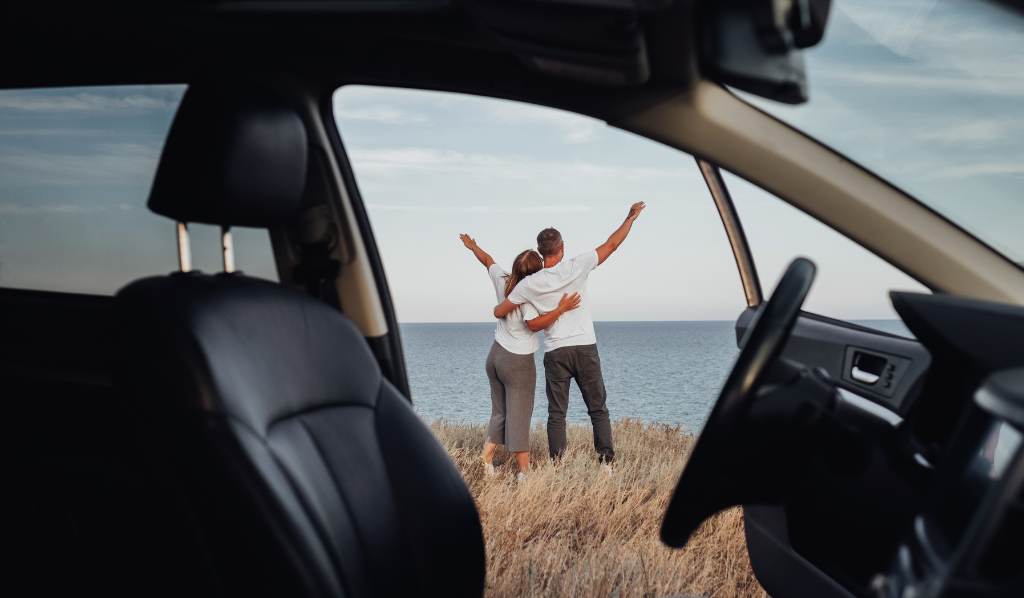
[0,0,694,94]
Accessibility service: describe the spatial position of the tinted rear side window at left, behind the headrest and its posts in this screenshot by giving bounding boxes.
[0,85,276,295]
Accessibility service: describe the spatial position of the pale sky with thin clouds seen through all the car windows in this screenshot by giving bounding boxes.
[0,0,1024,322]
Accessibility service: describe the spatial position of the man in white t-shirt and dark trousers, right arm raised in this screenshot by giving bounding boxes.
[495,202,646,464]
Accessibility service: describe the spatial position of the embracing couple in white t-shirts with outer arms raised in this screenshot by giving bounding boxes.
[460,202,645,479]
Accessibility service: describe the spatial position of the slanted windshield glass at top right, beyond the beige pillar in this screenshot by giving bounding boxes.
[743,0,1024,263]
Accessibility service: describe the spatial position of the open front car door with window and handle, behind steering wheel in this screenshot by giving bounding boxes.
[698,160,931,596]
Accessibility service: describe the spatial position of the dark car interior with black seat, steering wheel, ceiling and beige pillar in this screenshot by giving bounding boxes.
[6,0,1024,597]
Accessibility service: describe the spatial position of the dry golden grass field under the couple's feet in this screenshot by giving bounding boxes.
[433,420,767,598]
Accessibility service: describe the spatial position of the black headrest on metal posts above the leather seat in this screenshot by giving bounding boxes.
[148,84,308,227]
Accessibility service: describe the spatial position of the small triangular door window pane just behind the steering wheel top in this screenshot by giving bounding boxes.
[722,171,929,336]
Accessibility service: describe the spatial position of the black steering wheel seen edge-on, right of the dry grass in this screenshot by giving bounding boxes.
[662,258,816,548]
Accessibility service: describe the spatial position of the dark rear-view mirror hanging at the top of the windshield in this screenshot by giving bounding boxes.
[699,0,831,103]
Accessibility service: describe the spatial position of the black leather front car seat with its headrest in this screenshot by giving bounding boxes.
[115,85,484,597]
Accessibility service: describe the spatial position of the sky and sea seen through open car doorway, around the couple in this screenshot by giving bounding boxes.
[334,86,745,431]
